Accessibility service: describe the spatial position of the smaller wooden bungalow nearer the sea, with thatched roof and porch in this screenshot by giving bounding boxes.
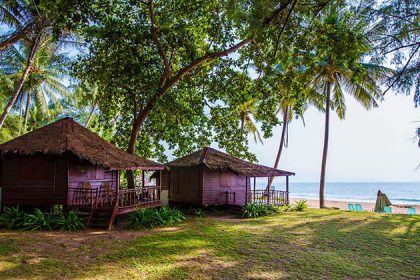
[161,148,295,206]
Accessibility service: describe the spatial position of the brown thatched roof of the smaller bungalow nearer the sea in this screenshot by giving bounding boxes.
[166,147,295,177]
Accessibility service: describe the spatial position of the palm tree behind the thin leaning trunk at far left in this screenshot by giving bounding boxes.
[0,40,68,133]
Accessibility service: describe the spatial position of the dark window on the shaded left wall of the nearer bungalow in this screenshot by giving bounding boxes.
[20,155,53,180]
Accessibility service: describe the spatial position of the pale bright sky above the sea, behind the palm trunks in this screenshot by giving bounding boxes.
[244,93,420,184]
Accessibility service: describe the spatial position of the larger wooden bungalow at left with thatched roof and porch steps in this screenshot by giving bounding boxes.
[0,118,164,228]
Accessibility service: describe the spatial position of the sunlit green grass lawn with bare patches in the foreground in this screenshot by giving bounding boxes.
[0,209,420,280]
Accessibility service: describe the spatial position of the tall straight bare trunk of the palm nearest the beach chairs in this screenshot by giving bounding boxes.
[319,82,331,208]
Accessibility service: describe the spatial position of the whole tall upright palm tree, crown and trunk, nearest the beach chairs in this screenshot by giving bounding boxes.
[311,5,389,208]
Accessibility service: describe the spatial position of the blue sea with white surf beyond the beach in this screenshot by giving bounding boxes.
[251,181,420,205]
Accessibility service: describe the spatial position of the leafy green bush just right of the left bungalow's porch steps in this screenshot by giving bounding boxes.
[129,206,185,229]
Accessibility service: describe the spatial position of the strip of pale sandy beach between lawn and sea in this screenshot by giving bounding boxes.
[290,198,420,214]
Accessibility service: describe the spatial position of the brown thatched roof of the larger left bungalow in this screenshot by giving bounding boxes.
[0,118,164,170]
